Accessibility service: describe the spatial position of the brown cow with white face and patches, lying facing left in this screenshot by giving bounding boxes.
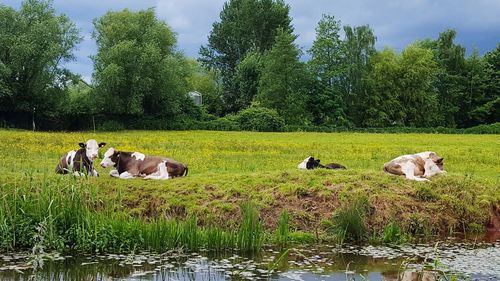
[101,148,188,180]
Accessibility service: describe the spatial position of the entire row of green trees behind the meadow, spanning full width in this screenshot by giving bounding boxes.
[0,0,500,130]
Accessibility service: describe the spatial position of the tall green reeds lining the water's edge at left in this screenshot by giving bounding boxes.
[0,177,263,253]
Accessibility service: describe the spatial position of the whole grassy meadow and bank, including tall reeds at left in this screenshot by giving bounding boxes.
[0,130,500,251]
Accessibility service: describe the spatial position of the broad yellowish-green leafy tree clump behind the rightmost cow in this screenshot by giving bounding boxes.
[362,45,439,127]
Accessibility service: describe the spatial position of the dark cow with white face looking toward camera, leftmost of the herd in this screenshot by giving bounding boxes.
[56,139,106,177]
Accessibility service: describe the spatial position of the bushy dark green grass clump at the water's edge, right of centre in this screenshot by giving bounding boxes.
[332,197,369,243]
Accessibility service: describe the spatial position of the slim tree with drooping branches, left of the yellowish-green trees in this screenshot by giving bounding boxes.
[341,25,376,126]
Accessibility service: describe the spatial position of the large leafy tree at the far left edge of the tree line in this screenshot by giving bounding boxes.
[0,0,81,116]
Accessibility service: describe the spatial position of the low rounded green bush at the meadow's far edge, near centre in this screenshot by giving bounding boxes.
[238,106,285,132]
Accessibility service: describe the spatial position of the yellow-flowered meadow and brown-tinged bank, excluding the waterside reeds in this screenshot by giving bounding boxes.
[0,130,500,250]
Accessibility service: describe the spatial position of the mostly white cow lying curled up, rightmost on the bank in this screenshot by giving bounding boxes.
[384,151,446,181]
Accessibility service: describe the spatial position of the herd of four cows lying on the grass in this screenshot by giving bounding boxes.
[56,139,446,181]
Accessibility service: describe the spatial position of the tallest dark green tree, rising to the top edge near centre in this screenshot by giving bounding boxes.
[199,0,292,113]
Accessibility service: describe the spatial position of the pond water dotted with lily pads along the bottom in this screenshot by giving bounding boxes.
[0,238,500,281]
